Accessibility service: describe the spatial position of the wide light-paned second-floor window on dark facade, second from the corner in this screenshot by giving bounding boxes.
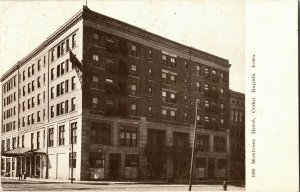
[120,126,137,147]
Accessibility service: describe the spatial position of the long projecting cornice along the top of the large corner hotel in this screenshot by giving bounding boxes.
[0,5,231,82]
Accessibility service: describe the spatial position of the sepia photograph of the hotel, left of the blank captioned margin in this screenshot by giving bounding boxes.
[0,0,288,191]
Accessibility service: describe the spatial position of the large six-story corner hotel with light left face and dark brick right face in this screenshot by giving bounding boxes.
[1,6,230,180]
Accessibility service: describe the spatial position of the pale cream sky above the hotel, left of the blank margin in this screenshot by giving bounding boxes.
[0,0,245,92]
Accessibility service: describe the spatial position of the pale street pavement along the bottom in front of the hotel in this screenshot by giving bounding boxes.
[1,178,245,191]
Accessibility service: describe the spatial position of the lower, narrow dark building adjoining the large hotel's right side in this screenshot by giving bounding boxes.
[230,90,245,180]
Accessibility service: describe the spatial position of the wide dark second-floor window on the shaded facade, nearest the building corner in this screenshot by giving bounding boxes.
[91,122,111,145]
